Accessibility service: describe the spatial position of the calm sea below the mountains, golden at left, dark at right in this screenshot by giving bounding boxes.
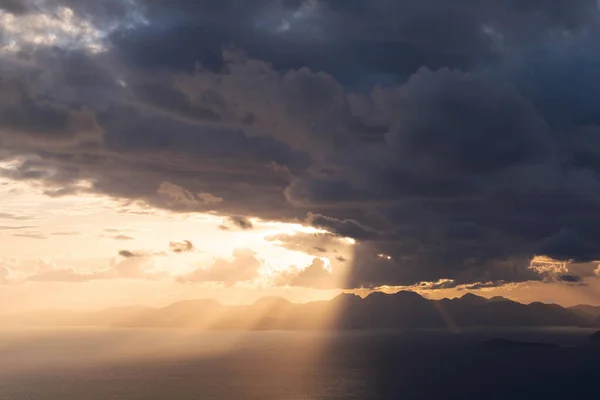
[0,328,600,400]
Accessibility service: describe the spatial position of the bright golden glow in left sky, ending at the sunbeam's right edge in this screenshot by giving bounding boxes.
[0,177,354,311]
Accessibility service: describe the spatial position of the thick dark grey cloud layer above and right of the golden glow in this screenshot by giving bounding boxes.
[0,0,600,287]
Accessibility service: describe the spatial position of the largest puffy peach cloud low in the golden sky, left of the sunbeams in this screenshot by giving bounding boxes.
[177,249,261,286]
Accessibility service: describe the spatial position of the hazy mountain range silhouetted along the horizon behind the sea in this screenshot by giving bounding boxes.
[0,291,600,330]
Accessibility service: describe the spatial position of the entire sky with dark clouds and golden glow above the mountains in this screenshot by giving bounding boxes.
[0,0,600,312]
